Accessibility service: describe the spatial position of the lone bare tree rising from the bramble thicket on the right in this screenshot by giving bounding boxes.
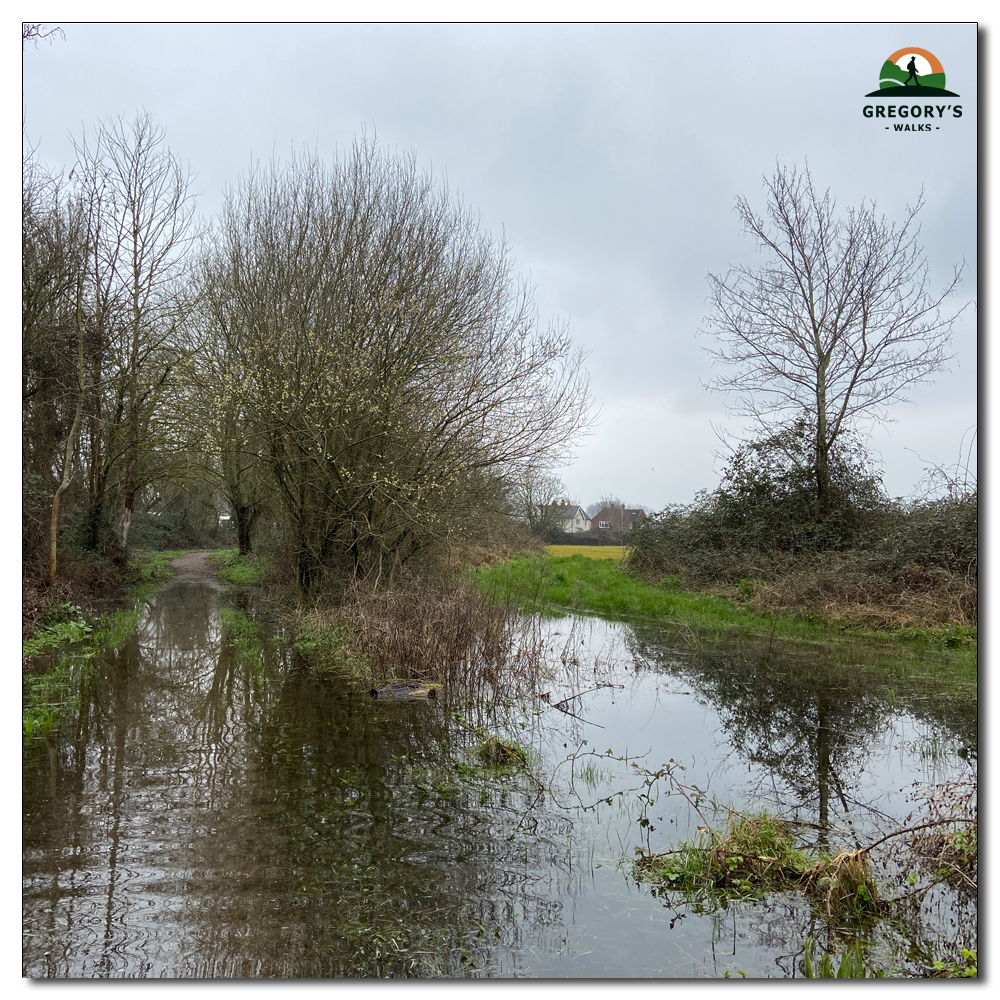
[707,167,962,512]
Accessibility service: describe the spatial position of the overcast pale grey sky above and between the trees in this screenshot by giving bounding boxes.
[24,24,977,508]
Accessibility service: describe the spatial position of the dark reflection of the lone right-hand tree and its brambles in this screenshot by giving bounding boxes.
[627,626,976,976]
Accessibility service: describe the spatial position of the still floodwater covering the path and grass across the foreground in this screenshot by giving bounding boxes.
[23,582,977,978]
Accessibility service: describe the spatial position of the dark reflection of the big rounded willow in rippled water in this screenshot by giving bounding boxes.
[203,656,580,976]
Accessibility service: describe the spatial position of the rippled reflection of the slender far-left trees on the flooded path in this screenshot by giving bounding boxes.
[24,588,234,977]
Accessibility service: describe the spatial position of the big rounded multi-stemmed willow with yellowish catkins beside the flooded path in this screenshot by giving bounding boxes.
[203,142,588,589]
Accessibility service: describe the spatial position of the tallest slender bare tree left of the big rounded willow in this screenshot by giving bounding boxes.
[74,114,193,548]
